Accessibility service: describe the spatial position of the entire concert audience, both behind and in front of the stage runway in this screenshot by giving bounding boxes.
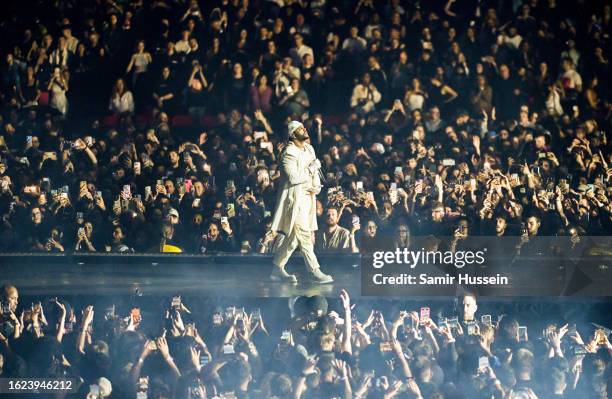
[0,0,612,399]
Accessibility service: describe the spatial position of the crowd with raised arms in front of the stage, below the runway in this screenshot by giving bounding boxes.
[0,286,612,399]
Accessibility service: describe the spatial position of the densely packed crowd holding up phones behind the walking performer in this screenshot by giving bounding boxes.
[0,0,612,254]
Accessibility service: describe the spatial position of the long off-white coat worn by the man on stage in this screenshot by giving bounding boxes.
[271,142,321,235]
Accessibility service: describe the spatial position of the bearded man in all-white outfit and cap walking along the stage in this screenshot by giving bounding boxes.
[270,121,334,284]
